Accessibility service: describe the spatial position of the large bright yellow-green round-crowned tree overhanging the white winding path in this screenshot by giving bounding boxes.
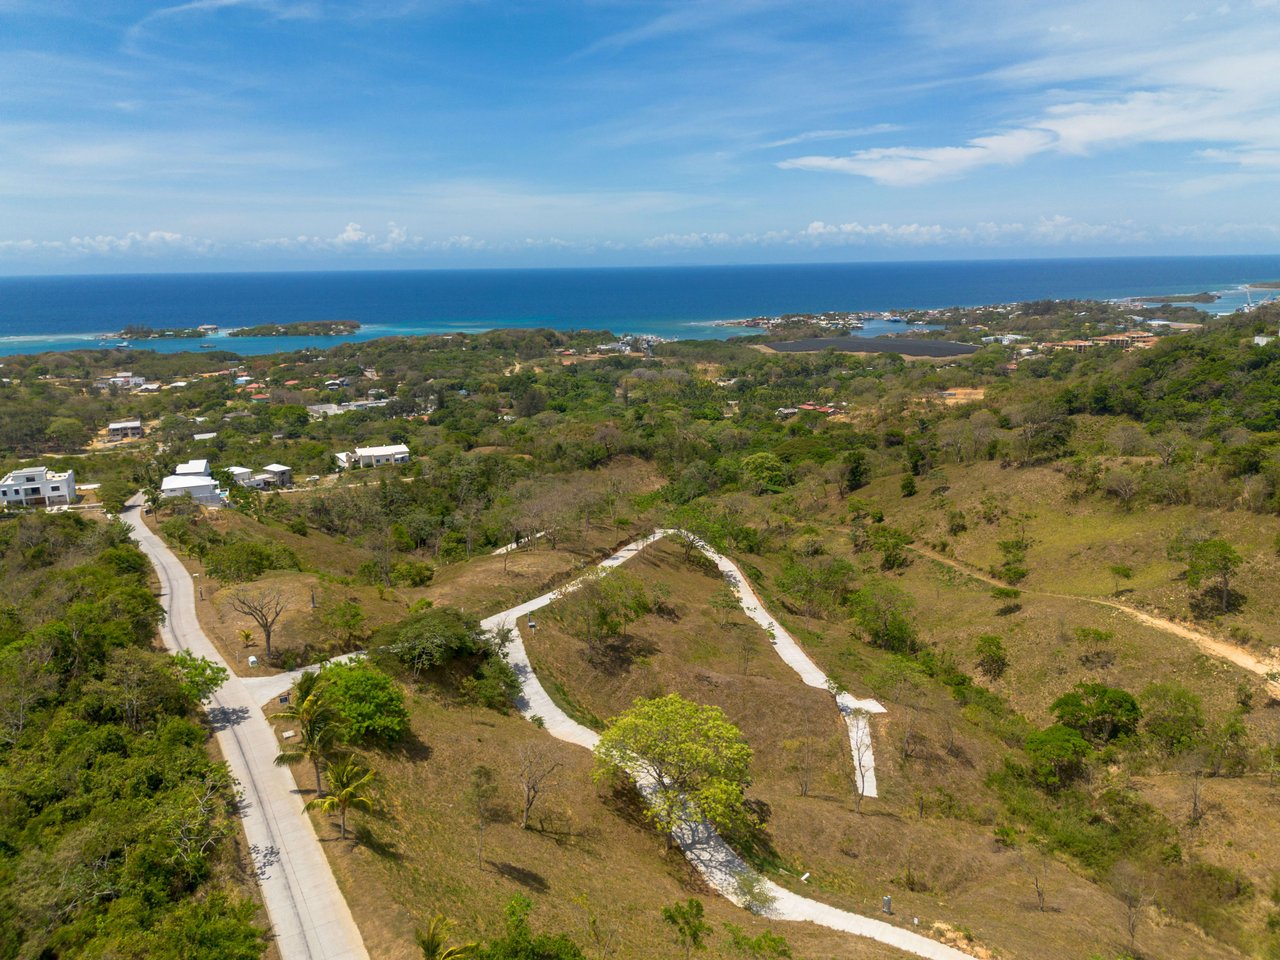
[595,694,755,844]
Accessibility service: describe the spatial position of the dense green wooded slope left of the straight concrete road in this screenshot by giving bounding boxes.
[0,513,265,960]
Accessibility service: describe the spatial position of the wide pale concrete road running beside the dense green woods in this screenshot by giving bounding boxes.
[122,503,369,960]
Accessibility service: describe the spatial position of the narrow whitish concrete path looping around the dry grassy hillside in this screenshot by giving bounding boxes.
[481,530,973,960]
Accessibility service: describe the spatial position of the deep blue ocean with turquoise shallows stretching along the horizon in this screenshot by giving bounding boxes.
[0,256,1280,356]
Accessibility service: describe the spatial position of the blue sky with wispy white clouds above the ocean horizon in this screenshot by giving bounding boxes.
[0,0,1280,274]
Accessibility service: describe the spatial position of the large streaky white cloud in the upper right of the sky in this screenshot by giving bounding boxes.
[777,0,1280,187]
